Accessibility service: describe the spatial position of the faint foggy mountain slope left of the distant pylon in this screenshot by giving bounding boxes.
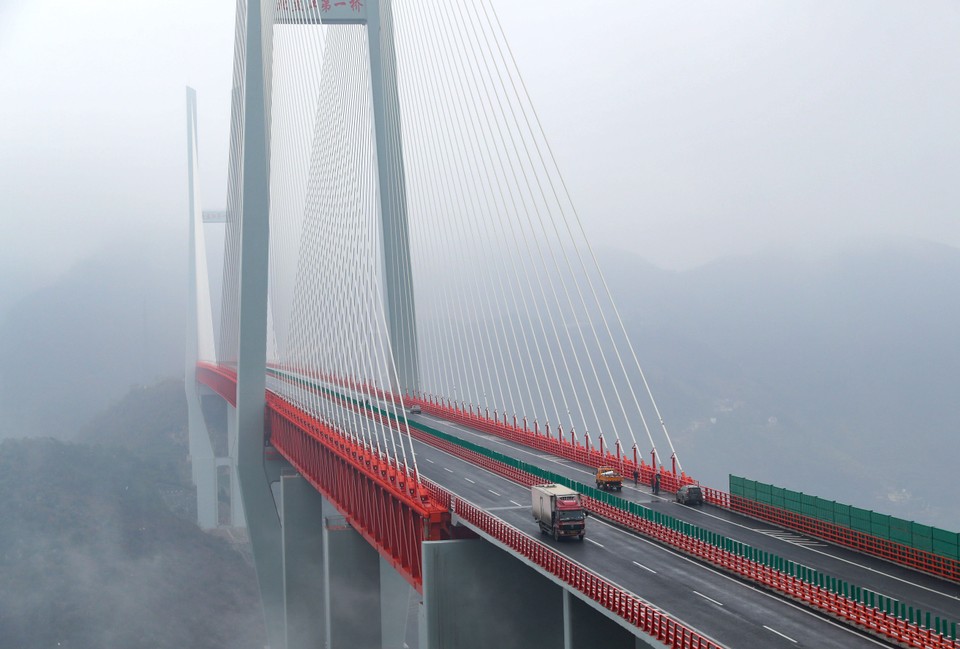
[0,249,185,439]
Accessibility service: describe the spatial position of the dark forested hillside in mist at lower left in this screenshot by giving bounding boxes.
[0,381,265,649]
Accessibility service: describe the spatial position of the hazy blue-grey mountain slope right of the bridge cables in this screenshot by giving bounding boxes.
[603,243,960,529]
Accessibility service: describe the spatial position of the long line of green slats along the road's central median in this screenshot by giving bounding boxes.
[270,370,957,640]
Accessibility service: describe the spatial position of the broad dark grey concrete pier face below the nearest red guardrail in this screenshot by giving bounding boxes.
[420,540,564,649]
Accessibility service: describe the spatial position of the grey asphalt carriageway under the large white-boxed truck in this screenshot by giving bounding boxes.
[415,420,885,649]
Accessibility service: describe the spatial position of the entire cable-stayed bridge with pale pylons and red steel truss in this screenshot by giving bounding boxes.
[186,0,960,649]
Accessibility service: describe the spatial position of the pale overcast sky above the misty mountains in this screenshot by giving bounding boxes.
[0,0,960,300]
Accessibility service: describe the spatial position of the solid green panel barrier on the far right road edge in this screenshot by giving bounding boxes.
[730,475,960,561]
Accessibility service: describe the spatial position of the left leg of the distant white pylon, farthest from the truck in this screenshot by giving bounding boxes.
[183,88,219,529]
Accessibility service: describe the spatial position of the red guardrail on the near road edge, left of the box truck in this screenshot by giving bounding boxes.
[453,498,722,649]
